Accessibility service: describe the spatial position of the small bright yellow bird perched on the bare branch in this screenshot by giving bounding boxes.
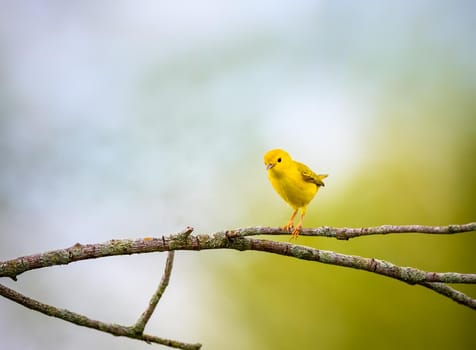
[264,149,327,239]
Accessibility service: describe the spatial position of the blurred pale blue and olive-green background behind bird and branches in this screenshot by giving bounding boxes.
[0,0,476,349]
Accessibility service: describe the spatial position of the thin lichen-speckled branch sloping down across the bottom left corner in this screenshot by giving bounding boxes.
[0,284,201,350]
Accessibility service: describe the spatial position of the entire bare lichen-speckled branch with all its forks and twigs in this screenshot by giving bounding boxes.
[0,222,476,349]
